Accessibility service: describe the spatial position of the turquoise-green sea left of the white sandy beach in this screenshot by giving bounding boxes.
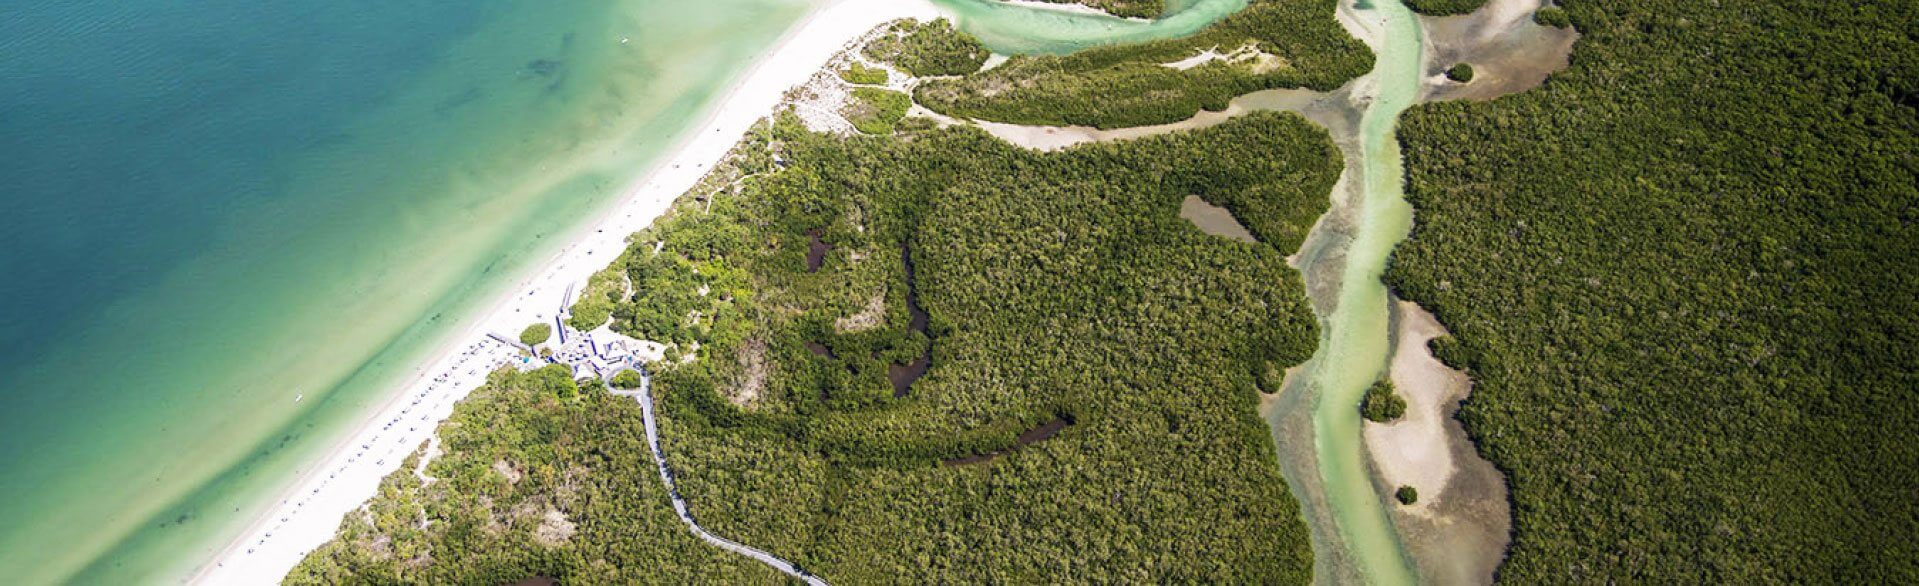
[0,0,806,584]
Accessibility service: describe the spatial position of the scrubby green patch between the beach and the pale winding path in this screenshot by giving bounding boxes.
[284,367,785,584]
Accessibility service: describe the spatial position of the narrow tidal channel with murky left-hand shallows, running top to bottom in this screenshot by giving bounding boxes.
[1267,0,1424,584]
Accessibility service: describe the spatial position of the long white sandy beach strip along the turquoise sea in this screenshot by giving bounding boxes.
[190,0,940,584]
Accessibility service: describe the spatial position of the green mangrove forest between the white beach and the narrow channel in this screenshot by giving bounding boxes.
[299,97,1341,582]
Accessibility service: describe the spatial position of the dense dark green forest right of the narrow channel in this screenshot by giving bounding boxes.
[1389,0,1919,584]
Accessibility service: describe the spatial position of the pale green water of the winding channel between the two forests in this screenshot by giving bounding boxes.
[1305,0,1424,584]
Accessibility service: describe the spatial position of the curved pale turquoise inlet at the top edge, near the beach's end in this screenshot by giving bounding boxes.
[933,0,1247,56]
